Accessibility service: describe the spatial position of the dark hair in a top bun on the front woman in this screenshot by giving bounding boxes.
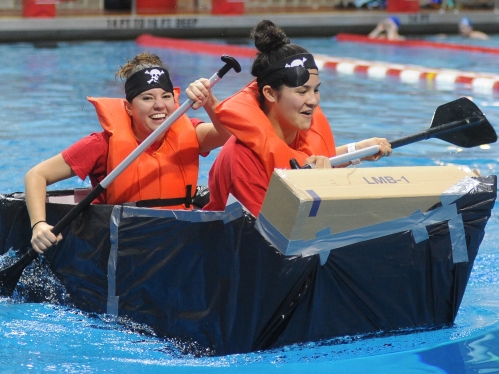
[251,20,308,105]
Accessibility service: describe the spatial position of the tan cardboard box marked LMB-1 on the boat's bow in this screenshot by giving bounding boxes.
[257,166,479,255]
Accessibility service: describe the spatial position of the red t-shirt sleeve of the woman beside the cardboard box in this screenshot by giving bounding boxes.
[203,136,270,217]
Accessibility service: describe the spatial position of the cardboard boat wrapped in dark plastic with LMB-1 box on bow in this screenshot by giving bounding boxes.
[0,166,497,355]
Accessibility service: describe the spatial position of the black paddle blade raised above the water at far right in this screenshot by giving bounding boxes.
[431,97,497,148]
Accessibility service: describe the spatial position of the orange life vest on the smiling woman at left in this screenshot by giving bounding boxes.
[88,88,199,209]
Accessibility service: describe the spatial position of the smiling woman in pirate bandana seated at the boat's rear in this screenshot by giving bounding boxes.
[25,53,230,253]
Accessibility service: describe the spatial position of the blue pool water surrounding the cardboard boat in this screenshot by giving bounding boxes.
[0,37,499,374]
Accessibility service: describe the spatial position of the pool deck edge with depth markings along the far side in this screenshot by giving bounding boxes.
[0,9,499,43]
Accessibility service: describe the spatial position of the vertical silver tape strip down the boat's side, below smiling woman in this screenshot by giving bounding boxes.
[107,205,121,316]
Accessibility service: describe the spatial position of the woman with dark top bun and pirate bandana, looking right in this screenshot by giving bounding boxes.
[204,21,392,216]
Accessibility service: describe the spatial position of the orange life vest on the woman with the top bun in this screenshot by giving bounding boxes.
[216,81,336,179]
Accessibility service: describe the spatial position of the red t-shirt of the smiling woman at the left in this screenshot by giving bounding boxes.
[62,118,206,202]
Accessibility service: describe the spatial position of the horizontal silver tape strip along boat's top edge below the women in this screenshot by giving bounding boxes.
[122,202,243,223]
